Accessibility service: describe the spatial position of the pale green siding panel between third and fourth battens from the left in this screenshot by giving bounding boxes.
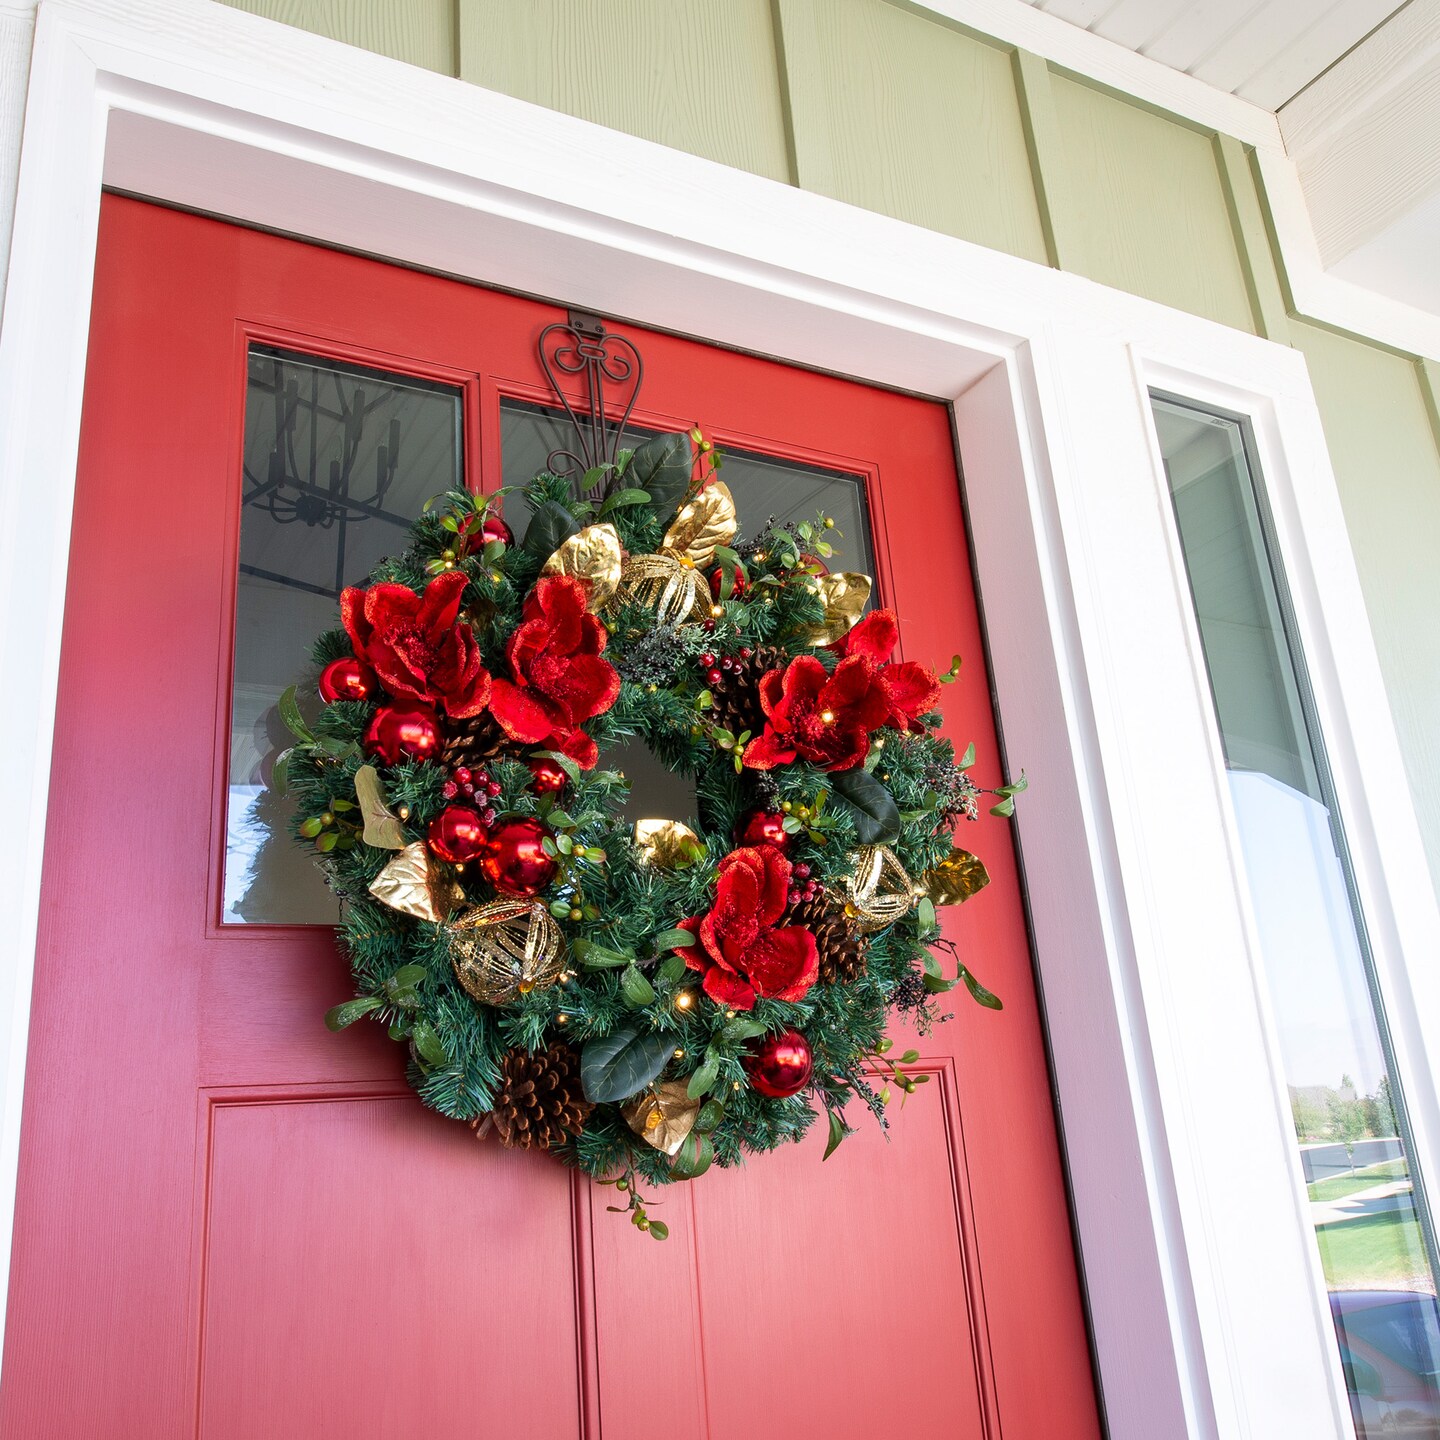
[1051,75,1254,330]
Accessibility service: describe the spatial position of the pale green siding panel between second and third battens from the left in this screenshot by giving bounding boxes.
[775,0,1047,262]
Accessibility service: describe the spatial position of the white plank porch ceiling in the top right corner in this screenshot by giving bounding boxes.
[1025,0,1404,109]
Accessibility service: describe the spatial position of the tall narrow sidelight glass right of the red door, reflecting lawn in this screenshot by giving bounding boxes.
[1153,396,1440,1440]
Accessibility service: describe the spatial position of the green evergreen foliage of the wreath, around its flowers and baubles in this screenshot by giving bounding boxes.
[281,436,1022,1234]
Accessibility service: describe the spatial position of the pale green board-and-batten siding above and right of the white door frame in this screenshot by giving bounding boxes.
[216,0,1440,888]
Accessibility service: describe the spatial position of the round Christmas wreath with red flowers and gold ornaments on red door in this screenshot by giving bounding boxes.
[278,432,1024,1238]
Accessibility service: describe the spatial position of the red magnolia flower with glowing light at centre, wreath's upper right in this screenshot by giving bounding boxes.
[743,655,890,770]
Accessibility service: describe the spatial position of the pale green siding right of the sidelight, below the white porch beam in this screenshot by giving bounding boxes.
[1290,320,1440,883]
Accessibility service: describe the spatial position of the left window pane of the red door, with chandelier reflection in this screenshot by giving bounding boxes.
[222,346,464,924]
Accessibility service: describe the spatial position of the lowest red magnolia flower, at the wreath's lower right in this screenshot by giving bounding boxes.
[678,845,819,1009]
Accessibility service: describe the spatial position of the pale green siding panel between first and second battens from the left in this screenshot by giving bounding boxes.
[458,0,791,180]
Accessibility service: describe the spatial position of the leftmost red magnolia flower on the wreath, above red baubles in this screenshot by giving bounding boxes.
[340,570,490,719]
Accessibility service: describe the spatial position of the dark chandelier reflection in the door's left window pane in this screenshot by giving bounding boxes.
[242,354,405,531]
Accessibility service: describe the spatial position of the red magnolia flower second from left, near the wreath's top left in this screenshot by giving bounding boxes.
[490,575,621,770]
